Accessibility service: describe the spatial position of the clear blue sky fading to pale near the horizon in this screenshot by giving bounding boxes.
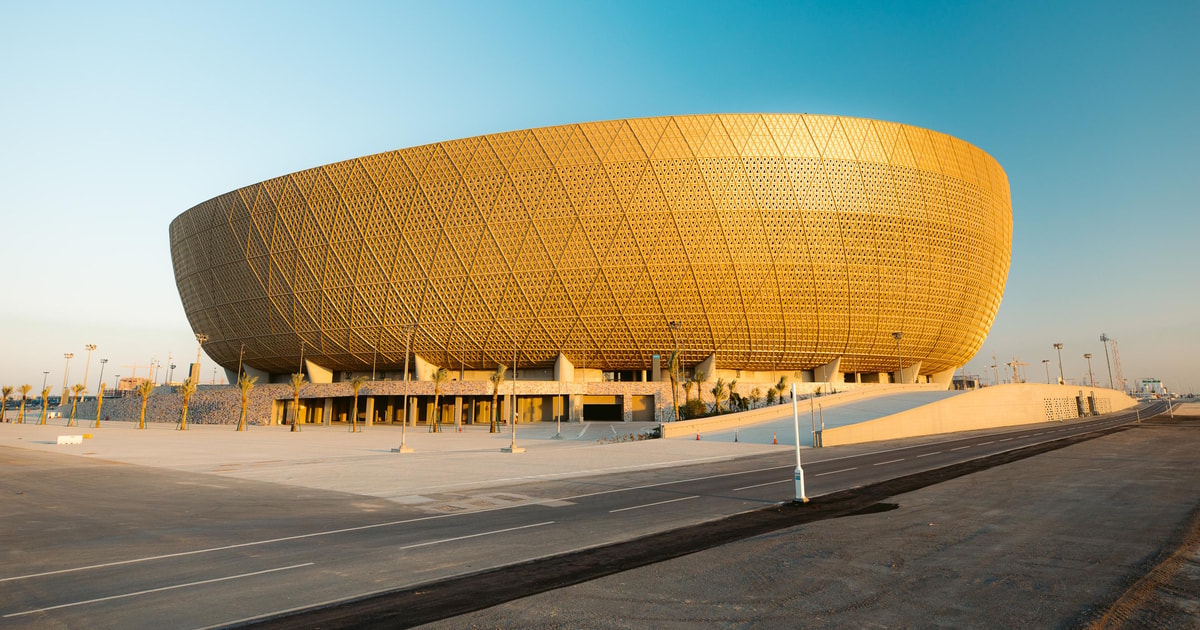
[0,0,1200,394]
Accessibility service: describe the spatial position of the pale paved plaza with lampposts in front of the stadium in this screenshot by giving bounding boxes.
[0,419,786,503]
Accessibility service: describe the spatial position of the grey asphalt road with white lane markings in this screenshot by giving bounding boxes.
[0,407,1158,628]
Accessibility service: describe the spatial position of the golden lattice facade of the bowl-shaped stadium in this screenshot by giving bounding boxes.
[170,114,1012,373]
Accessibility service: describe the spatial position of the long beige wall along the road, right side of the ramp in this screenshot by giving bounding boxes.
[822,383,1138,446]
